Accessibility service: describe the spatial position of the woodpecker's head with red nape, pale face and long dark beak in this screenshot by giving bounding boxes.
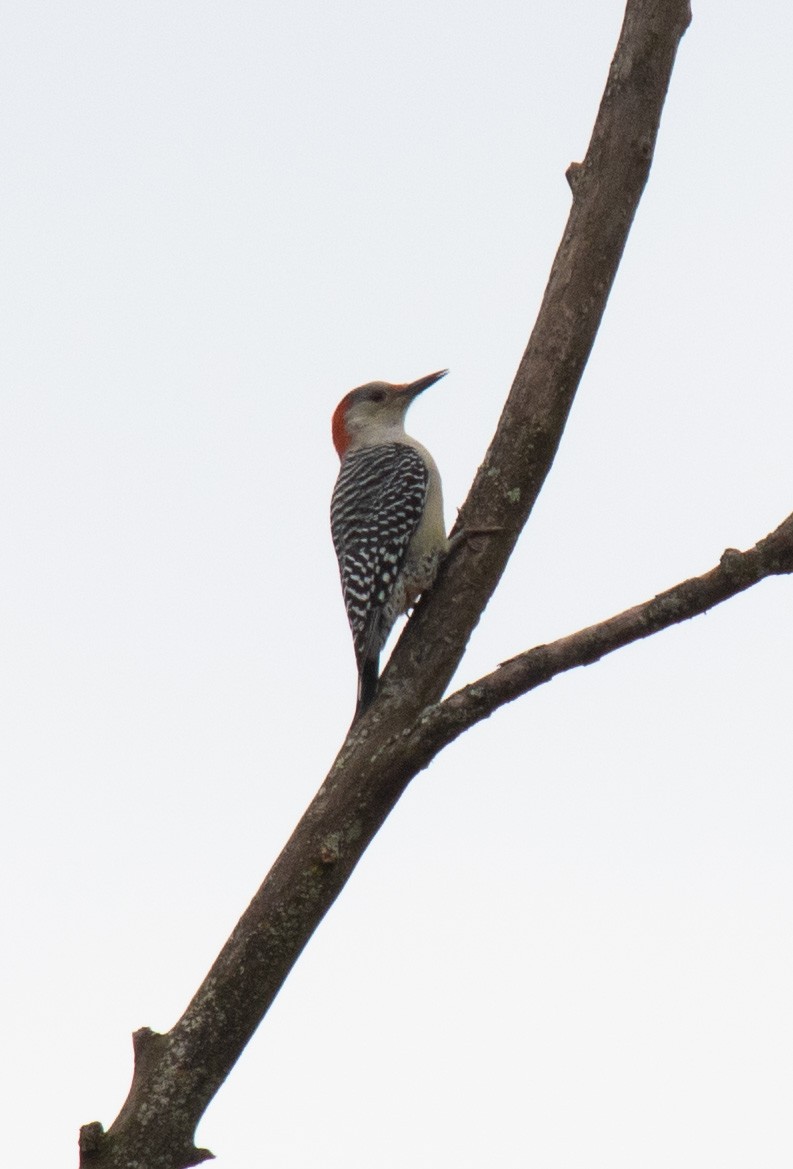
[332,369,449,458]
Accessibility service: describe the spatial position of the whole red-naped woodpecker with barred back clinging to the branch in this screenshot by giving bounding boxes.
[331,369,449,719]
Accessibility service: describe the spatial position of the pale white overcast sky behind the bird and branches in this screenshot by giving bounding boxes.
[0,0,793,1169]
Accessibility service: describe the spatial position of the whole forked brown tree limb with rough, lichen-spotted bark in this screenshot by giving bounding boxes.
[81,0,720,1169]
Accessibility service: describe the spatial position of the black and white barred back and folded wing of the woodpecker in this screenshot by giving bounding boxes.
[331,443,429,662]
